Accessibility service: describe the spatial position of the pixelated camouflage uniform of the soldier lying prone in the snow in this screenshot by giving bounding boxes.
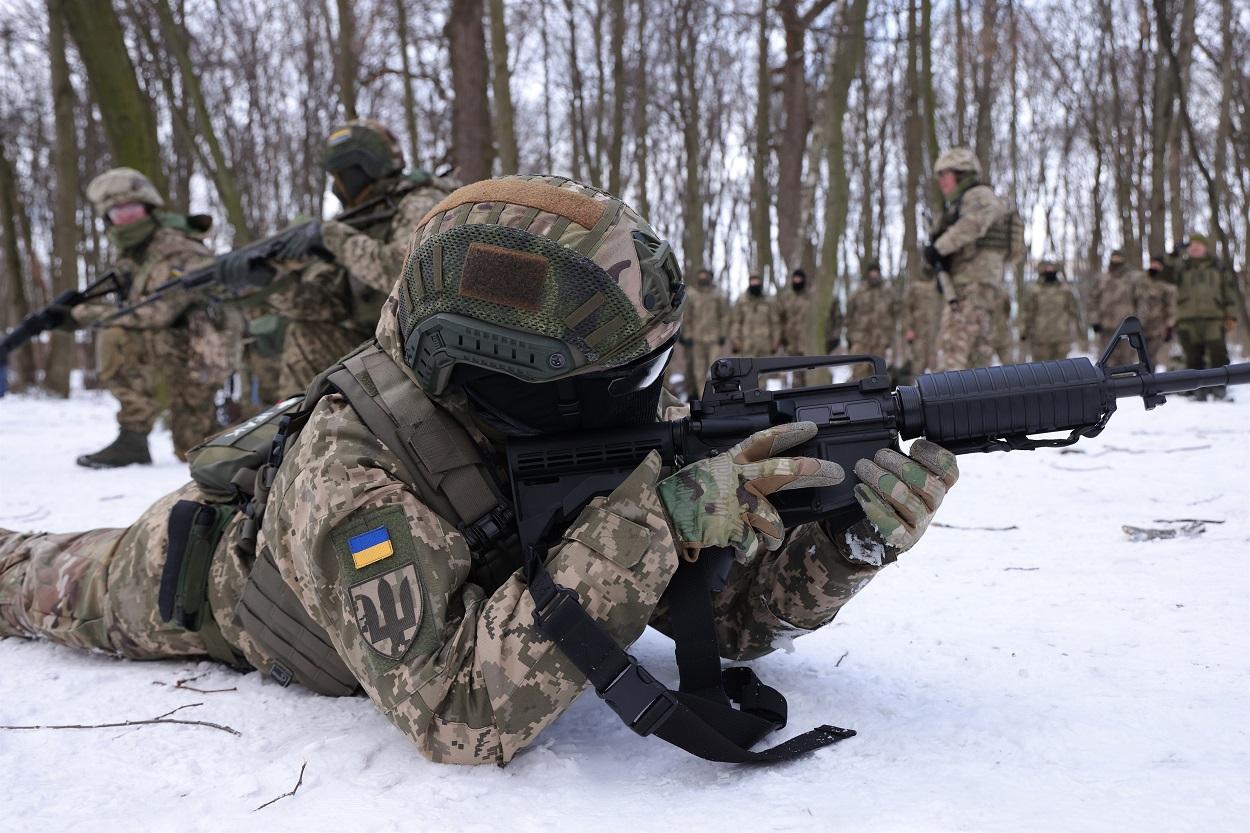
[0,176,905,763]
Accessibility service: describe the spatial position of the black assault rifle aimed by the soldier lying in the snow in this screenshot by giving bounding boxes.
[508,316,1250,548]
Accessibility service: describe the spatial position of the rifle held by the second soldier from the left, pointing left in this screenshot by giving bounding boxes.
[93,194,399,328]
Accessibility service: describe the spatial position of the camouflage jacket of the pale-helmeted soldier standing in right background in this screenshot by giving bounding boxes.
[929,185,1008,289]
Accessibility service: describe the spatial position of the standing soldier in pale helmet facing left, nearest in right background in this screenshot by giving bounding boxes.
[925,148,1010,370]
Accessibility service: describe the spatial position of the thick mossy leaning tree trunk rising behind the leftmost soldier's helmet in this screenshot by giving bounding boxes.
[61,0,169,194]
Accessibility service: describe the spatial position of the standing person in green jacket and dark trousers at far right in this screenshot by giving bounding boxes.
[1165,228,1236,399]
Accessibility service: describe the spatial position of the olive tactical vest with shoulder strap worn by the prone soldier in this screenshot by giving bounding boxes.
[173,341,521,697]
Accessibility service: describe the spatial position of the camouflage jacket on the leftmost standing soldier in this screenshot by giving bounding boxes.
[74,226,213,330]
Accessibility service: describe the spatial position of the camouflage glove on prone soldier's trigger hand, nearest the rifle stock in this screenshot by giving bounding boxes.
[659,423,846,563]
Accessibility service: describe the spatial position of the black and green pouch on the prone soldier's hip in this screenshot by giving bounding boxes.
[158,500,245,668]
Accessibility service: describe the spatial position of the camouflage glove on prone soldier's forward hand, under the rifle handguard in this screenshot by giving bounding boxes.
[846,439,959,564]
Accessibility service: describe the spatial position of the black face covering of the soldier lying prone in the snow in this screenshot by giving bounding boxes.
[453,343,673,437]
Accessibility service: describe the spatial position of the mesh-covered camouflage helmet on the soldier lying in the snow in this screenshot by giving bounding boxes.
[390,176,685,394]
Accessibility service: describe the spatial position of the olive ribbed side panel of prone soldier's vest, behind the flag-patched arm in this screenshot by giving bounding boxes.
[235,549,359,697]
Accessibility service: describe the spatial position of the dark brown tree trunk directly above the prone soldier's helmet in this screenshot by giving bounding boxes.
[444,0,494,183]
